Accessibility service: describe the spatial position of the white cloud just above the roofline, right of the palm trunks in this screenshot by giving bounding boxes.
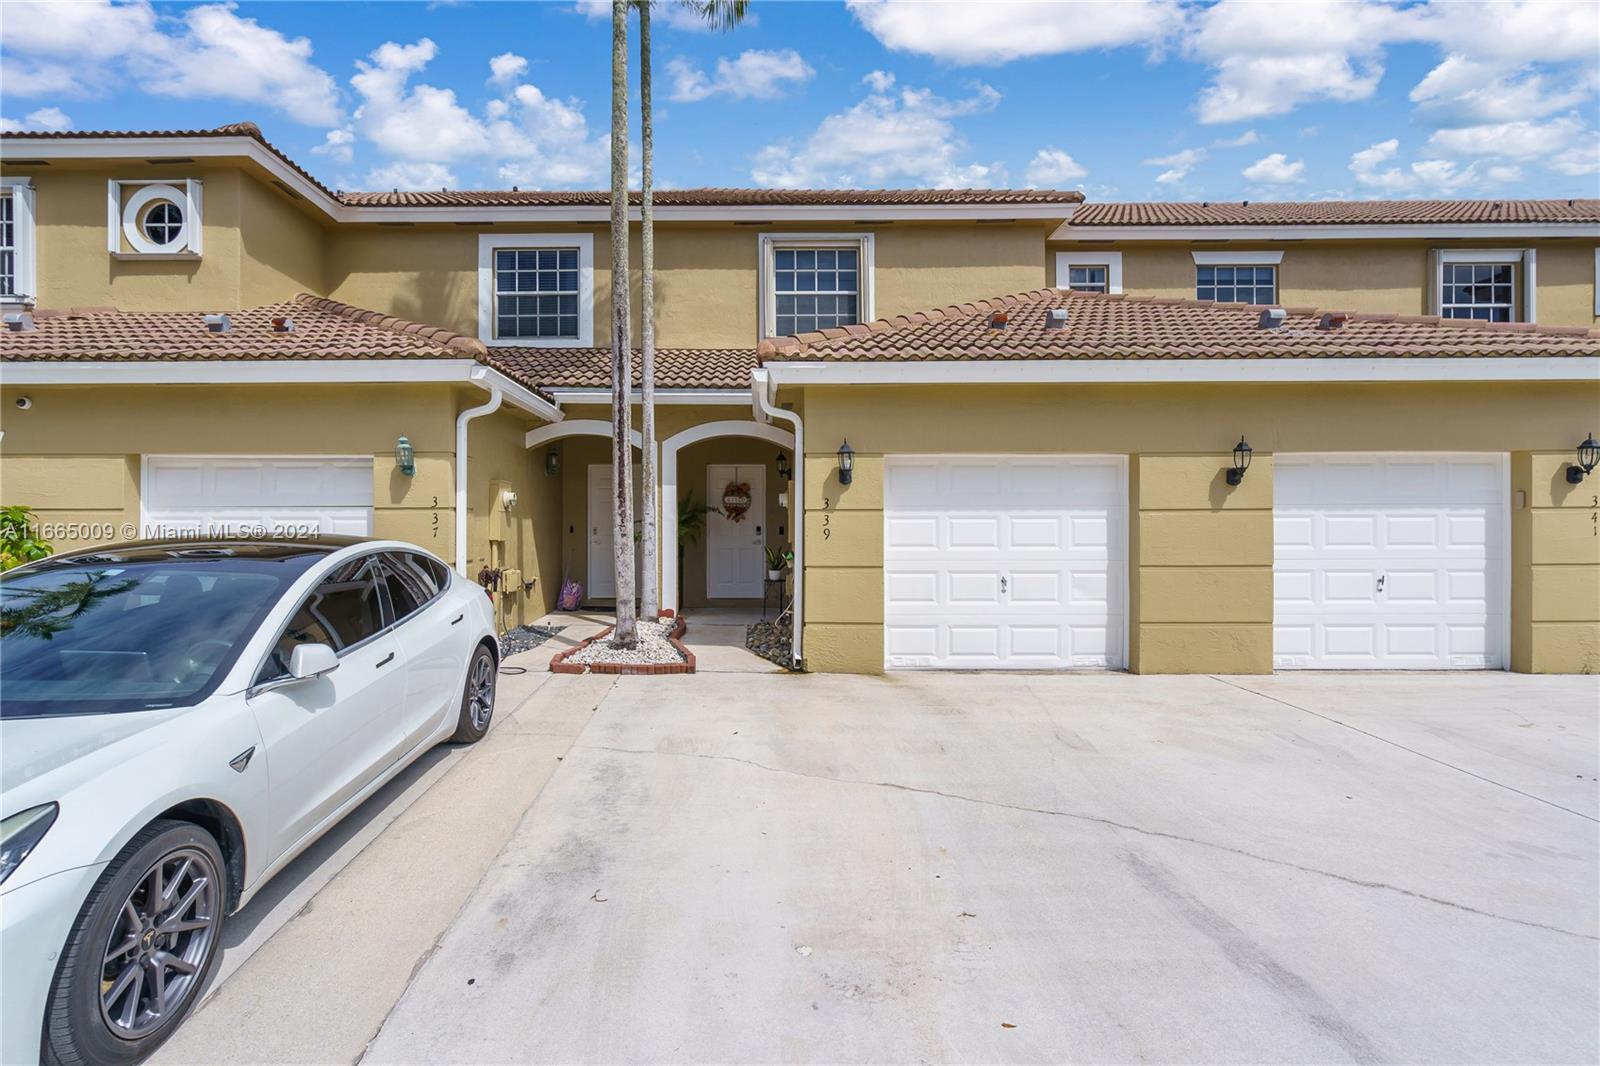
[750,72,1005,189]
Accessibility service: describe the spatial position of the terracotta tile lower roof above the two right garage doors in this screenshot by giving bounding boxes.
[758,288,1600,363]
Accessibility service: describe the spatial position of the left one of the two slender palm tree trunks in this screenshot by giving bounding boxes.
[611,0,638,648]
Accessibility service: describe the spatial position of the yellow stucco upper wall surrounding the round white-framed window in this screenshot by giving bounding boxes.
[6,160,326,312]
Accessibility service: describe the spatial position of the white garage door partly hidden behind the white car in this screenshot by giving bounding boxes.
[142,455,373,536]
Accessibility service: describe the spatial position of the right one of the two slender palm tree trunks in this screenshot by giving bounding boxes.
[638,0,656,619]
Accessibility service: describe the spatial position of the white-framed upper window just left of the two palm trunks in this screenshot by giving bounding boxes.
[478,234,595,347]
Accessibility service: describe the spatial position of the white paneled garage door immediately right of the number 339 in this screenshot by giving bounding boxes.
[883,456,1128,669]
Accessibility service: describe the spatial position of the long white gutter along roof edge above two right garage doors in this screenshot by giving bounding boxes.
[754,355,1600,387]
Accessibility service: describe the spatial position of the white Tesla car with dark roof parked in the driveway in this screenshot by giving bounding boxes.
[0,538,499,1064]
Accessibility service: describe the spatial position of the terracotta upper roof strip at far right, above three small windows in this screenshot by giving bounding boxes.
[1067,200,1600,229]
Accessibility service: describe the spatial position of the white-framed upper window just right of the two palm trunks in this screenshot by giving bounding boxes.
[760,234,874,336]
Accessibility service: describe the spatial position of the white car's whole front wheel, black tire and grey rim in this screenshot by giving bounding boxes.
[43,821,227,1066]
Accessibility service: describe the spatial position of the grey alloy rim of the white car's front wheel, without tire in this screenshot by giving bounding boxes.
[99,848,222,1040]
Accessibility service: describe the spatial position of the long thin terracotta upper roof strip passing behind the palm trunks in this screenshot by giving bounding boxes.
[339,189,1083,206]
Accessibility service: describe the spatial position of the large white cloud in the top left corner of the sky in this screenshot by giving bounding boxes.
[3,2,339,126]
